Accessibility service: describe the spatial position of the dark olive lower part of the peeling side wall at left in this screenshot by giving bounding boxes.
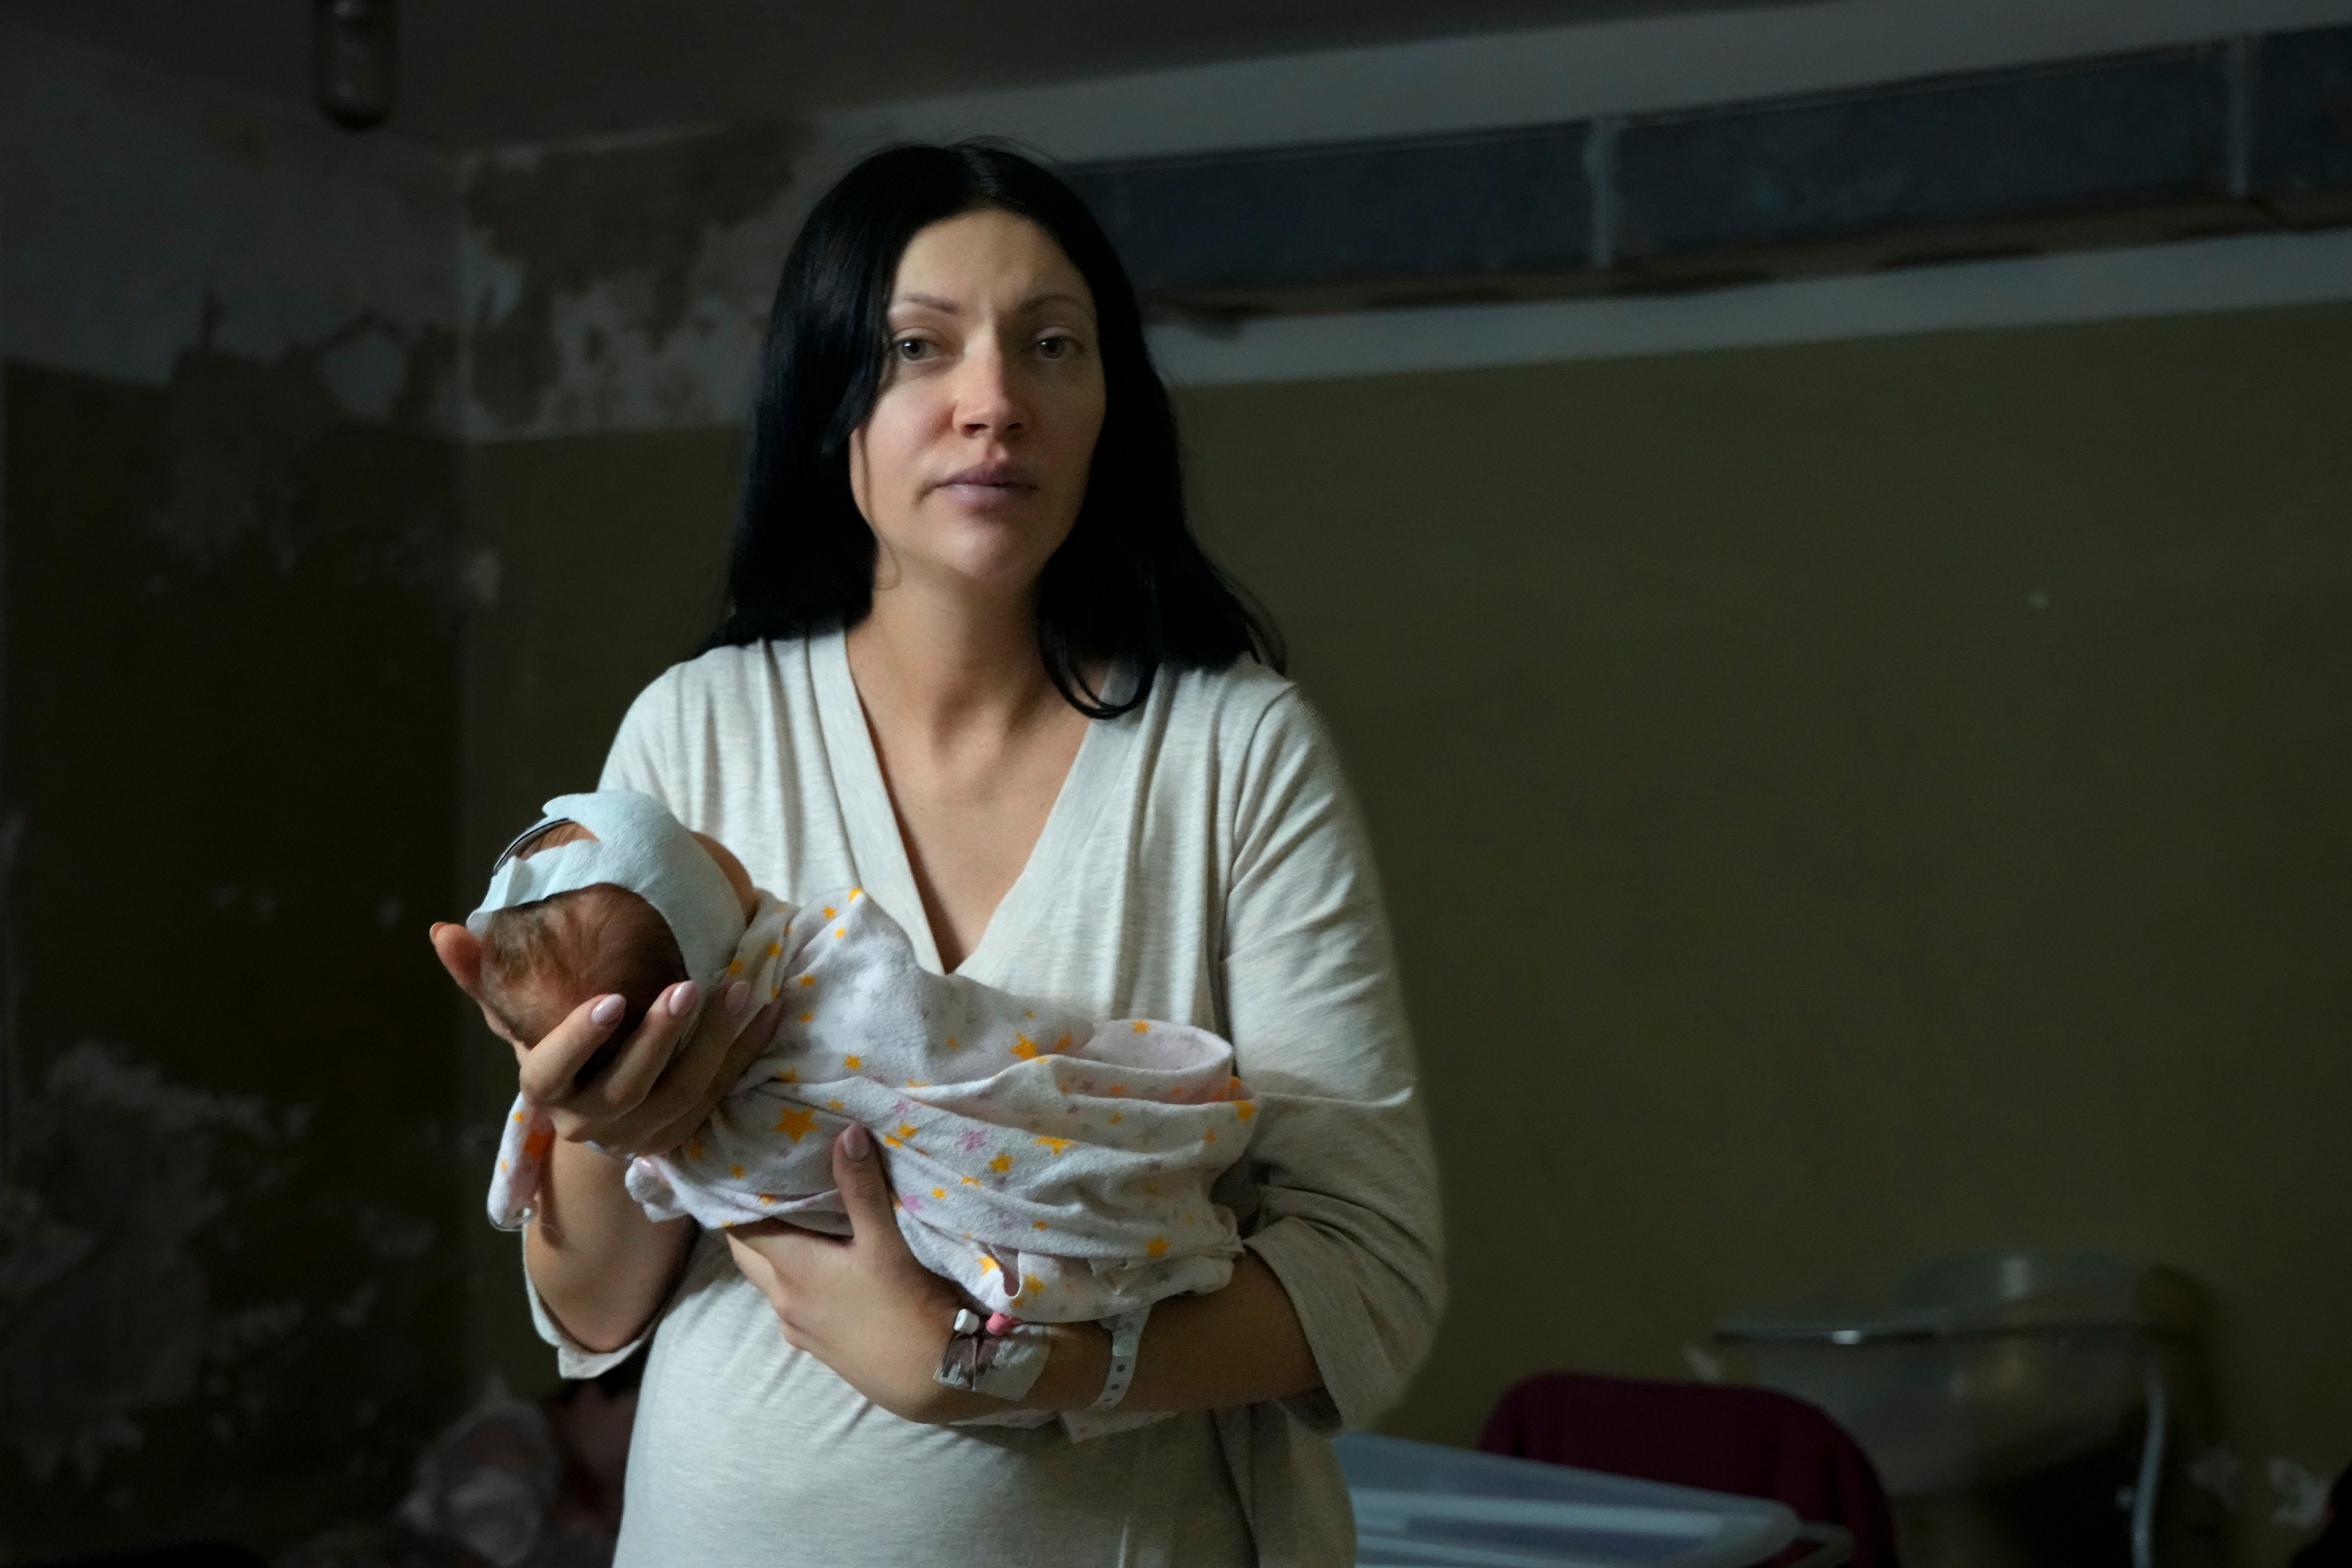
[0,362,480,1561]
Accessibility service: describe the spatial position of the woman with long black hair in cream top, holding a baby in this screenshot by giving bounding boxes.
[435,143,1439,1568]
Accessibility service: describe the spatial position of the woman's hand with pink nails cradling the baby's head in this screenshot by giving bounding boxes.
[433,922,781,1157]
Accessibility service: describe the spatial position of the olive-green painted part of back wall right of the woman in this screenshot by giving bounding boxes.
[1183,297,2352,1561]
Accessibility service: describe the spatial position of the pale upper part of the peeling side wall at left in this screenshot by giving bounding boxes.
[0,24,456,432]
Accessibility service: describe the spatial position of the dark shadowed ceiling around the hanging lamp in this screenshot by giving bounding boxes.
[0,0,1769,148]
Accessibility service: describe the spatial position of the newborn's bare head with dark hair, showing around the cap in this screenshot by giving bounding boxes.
[480,823,760,1046]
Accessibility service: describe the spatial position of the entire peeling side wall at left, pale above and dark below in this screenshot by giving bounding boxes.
[0,26,482,1561]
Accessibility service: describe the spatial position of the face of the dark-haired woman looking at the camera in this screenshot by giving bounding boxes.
[849,212,1103,595]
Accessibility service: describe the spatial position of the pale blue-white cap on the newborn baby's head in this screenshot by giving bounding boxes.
[466,790,746,997]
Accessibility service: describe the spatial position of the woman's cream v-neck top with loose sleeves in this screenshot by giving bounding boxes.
[534,632,1442,1568]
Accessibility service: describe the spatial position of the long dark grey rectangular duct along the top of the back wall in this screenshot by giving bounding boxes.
[1073,28,2352,318]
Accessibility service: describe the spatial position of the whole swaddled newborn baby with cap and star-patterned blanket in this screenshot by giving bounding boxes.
[466,790,1256,1363]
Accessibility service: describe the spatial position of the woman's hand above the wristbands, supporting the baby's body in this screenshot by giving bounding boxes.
[727,1124,988,1425]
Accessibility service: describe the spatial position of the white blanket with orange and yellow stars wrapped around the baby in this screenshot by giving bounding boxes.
[489,889,1256,1323]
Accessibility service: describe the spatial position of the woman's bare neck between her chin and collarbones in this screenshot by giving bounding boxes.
[849,583,1061,743]
